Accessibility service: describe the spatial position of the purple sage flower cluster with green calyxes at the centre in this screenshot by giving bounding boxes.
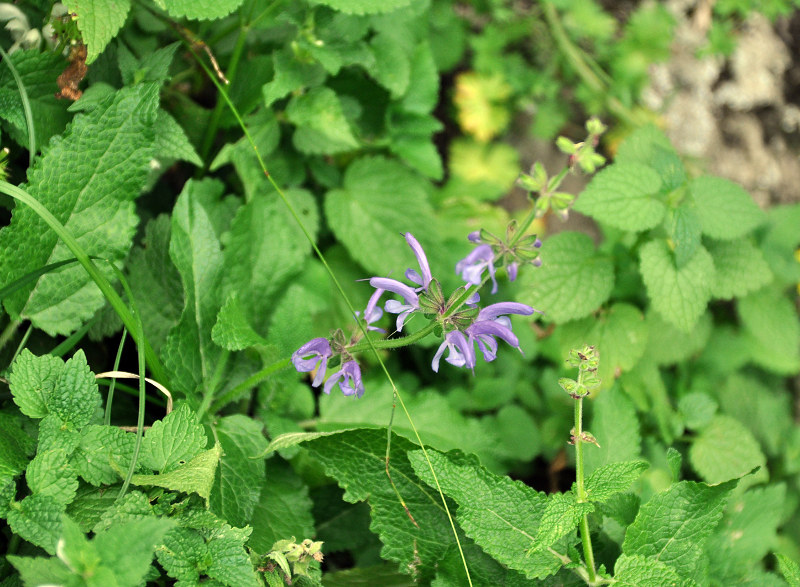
[292,232,541,397]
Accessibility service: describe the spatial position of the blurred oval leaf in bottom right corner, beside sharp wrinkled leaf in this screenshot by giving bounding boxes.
[706,483,786,584]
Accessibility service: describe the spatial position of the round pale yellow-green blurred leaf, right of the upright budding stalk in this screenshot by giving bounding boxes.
[689,415,767,483]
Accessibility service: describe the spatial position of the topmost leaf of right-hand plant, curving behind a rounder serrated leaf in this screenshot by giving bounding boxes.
[615,124,686,191]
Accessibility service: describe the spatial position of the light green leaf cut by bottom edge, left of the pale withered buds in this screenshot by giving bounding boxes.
[92,517,175,587]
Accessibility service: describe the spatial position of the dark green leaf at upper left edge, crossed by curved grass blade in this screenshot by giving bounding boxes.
[0,50,70,150]
